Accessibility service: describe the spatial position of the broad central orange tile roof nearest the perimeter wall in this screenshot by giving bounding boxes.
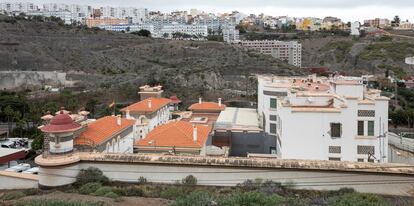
[135,121,211,148]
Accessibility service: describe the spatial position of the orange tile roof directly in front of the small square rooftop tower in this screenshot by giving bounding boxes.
[121,97,171,113]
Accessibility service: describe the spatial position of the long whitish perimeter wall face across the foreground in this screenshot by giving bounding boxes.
[39,162,414,195]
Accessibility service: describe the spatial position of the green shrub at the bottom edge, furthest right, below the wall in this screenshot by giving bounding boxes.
[328,192,390,206]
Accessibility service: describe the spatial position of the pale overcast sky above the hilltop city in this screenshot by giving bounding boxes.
[25,0,414,22]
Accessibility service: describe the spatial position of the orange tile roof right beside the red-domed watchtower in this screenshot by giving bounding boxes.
[75,116,135,145]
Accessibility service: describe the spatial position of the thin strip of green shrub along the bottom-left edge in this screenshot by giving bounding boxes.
[16,199,106,206]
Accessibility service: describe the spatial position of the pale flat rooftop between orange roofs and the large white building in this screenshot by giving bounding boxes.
[215,107,261,131]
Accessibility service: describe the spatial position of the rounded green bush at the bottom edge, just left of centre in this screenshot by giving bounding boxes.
[171,191,213,206]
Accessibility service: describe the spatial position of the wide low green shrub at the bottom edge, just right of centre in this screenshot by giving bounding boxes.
[218,192,285,206]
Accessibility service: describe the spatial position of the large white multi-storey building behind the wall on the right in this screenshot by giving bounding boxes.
[258,76,389,163]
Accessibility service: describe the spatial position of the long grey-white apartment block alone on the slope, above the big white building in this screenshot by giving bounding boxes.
[241,40,302,67]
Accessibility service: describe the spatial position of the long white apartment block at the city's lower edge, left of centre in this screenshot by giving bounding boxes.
[159,24,208,37]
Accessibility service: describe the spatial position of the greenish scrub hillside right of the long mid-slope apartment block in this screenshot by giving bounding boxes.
[301,37,414,78]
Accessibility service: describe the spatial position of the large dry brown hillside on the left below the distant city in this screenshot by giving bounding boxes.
[0,17,301,104]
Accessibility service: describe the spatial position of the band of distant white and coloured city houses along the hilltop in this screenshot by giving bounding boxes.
[0,2,414,40]
